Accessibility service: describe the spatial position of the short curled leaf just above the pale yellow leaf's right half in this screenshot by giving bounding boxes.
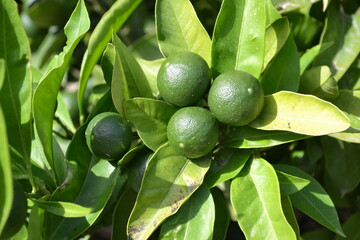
[299,66,339,99]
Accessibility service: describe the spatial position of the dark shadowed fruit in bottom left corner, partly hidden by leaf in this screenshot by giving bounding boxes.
[0,181,27,239]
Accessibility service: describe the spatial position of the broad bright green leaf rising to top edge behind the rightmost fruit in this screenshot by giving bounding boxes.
[211,0,266,78]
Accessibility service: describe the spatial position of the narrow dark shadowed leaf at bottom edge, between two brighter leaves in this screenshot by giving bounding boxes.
[211,187,230,240]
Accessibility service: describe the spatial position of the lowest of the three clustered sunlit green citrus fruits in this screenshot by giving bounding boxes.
[167,107,220,158]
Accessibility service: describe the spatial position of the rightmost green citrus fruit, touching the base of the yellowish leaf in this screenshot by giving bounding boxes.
[208,71,264,126]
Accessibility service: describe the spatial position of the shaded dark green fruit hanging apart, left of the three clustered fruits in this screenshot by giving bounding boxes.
[85,112,132,160]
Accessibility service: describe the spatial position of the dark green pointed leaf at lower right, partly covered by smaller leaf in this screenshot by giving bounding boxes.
[274,165,345,236]
